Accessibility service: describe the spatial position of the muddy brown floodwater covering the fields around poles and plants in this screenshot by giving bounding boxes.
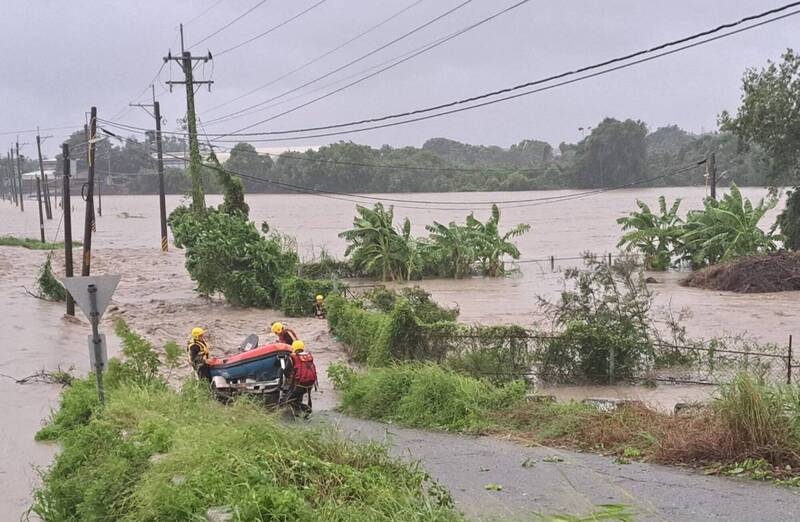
[0,188,800,519]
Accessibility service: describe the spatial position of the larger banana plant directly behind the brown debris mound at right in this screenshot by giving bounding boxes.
[682,185,783,267]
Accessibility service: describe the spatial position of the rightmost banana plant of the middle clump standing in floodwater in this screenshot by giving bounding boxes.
[467,205,531,277]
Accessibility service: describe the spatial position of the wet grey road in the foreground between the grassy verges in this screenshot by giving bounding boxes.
[320,412,800,522]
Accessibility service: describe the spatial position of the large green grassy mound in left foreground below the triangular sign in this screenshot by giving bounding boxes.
[32,324,461,522]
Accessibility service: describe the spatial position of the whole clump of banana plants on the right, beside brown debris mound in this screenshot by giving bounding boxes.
[617,185,790,270]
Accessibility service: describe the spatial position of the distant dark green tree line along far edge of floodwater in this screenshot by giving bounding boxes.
[34,118,782,194]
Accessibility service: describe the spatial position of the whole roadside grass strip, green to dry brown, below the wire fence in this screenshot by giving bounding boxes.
[330,365,800,485]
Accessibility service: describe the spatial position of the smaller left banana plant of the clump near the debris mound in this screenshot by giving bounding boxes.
[617,196,683,270]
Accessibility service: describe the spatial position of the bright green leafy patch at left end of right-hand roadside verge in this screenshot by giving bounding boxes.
[337,364,525,431]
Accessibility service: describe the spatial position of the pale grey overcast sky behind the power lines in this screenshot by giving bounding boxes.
[0,0,800,154]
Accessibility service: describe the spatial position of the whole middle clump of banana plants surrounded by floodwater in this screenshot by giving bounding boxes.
[339,203,530,281]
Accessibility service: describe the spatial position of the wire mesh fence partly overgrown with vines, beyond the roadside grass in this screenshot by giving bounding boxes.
[426,328,800,385]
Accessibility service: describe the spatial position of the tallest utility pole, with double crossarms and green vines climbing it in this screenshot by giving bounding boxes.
[164,24,214,212]
